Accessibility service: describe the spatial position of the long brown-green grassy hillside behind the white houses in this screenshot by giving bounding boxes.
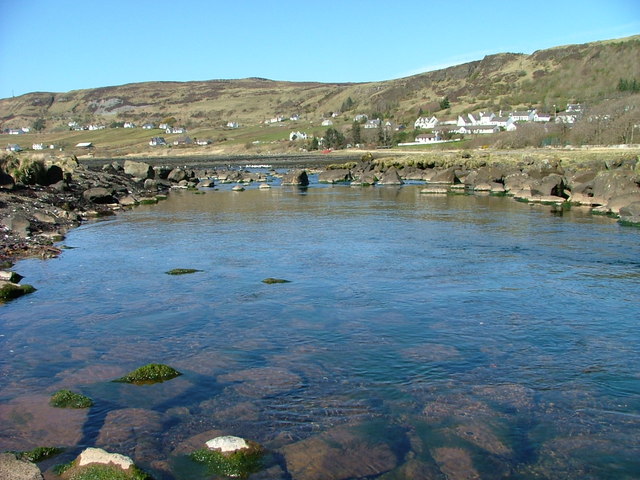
[0,35,640,156]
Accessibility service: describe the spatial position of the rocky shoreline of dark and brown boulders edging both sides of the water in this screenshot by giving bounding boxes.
[0,150,640,298]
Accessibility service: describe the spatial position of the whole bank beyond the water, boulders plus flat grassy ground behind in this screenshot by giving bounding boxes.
[0,149,640,263]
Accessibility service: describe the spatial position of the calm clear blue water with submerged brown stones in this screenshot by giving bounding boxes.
[0,181,640,479]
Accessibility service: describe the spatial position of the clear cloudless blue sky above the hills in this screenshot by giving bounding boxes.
[0,0,640,98]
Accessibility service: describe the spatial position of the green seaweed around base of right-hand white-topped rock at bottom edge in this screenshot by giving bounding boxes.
[189,442,264,478]
